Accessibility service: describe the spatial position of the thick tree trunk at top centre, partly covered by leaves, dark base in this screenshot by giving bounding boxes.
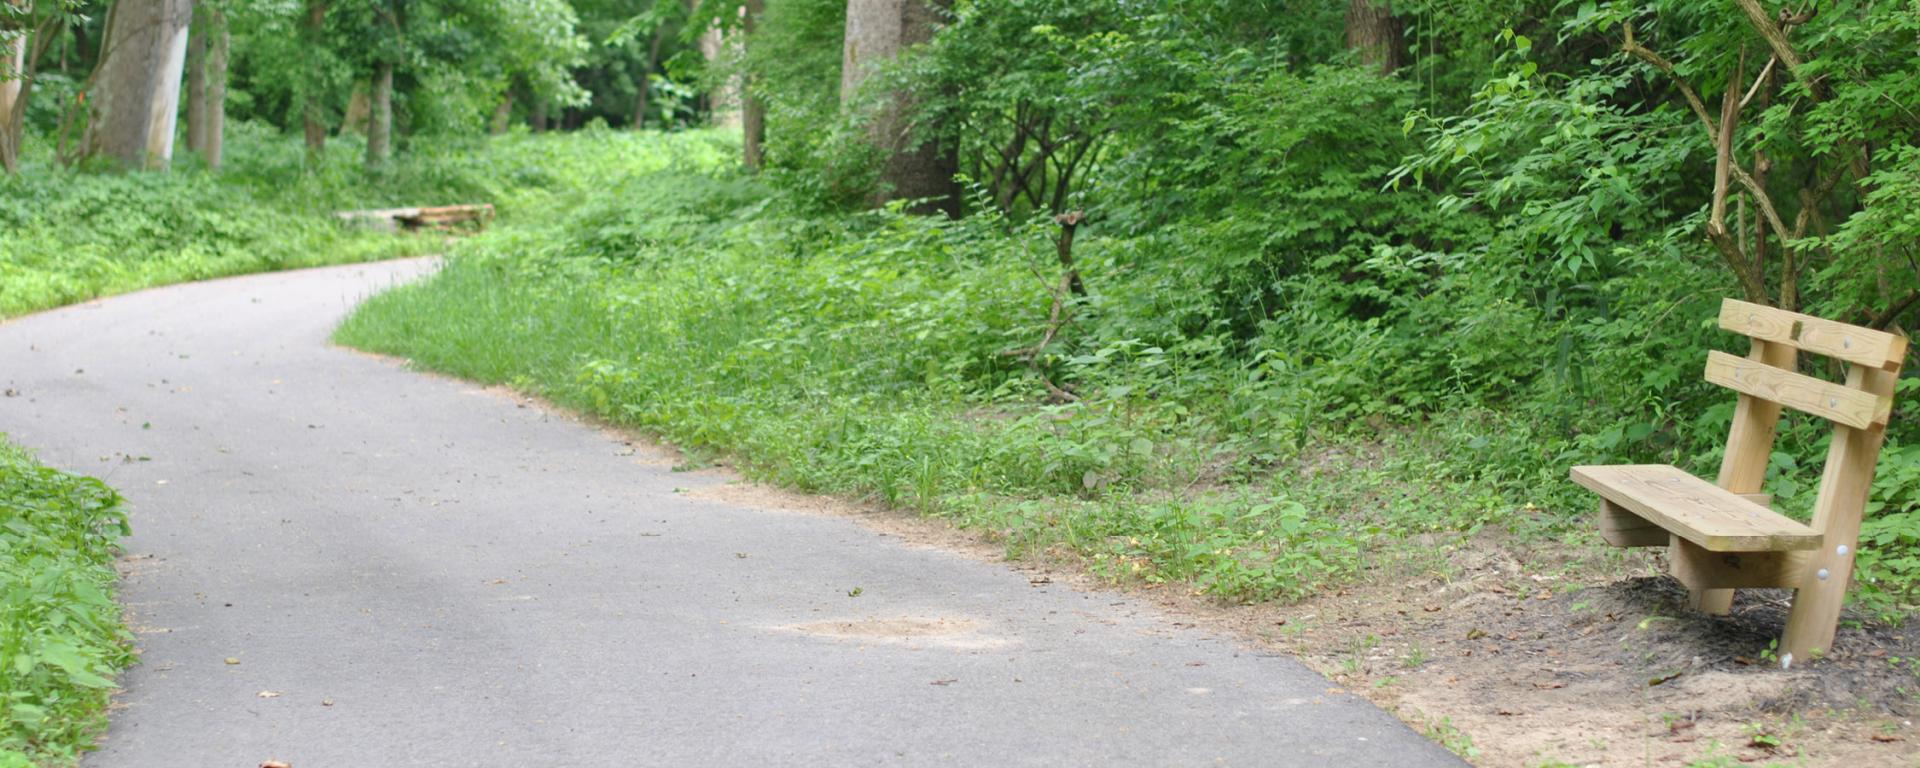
[841,0,960,215]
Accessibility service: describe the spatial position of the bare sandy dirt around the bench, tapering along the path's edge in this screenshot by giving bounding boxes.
[664,443,1920,768]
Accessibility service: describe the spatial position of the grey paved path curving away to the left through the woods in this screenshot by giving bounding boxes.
[0,261,1459,768]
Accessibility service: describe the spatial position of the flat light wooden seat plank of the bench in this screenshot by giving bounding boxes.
[1571,465,1820,553]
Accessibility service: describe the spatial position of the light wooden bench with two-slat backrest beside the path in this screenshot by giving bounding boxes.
[1572,300,1907,668]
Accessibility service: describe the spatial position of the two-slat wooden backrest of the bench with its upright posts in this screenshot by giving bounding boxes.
[1707,300,1907,529]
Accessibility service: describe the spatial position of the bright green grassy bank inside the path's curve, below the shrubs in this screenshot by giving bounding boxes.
[336,138,1559,601]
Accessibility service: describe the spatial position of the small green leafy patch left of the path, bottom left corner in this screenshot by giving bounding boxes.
[0,436,132,766]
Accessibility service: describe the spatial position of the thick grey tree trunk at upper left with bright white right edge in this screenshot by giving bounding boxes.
[86,0,194,171]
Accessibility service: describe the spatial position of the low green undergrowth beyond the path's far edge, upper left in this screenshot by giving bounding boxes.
[0,125,733,319]
